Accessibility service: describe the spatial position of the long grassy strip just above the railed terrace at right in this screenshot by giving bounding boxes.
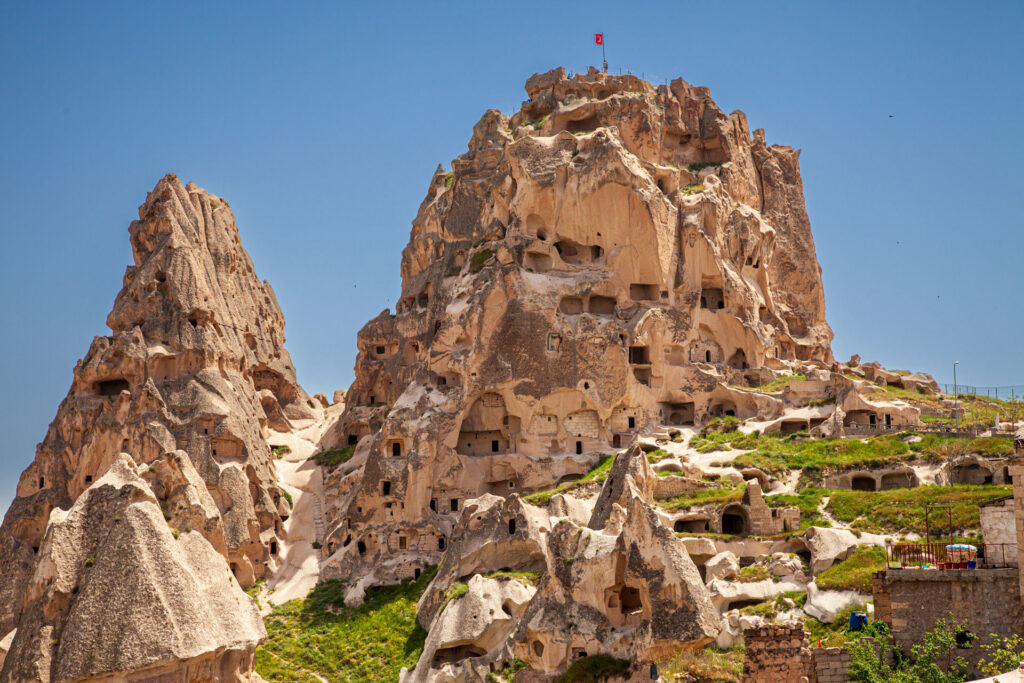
[827,484,1013,538]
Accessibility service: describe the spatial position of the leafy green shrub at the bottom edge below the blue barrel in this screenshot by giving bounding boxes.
[847,615,967,683]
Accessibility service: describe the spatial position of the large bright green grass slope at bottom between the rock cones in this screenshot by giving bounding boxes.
[256,568,435,683]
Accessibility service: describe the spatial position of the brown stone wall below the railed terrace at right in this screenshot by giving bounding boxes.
[871,568,1024,665]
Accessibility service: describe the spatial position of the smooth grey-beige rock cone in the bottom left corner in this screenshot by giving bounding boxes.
[0,454,266,682]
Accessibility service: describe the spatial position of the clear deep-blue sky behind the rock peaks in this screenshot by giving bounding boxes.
[0,0,1024,509]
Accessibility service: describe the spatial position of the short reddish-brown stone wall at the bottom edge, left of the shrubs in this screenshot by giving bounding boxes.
[743,624,814,683]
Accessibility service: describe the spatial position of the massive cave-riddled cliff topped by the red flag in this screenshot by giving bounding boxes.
[324,69,831,597]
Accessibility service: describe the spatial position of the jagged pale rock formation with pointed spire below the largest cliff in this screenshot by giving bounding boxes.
[403,449,720,683]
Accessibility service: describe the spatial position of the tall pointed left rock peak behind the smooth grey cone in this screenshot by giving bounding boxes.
[0,175,313,634]
